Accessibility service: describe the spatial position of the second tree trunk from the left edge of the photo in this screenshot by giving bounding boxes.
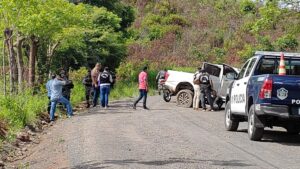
[16,35,25,92]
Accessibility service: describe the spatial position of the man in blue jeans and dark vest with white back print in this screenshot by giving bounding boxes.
[99,67,113,108]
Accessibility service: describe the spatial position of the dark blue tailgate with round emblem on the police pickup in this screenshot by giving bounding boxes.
[271,75,300,107]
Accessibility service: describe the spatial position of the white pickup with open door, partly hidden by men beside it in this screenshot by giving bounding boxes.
[164,62,238,109]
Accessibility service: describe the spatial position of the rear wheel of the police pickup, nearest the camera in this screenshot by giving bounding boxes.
[248,105,264,141]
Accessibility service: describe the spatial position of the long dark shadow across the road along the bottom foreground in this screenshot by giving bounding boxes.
[65,158,252,169]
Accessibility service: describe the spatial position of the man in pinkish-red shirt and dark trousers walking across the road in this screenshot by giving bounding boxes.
[133,66,149,110]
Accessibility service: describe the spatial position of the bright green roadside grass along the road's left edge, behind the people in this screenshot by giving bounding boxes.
[0,66,157,141]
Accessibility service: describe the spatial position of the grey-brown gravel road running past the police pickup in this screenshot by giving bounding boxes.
[11,96,300,169]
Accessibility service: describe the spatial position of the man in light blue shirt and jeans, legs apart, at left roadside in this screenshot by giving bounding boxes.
[50,75,73,122]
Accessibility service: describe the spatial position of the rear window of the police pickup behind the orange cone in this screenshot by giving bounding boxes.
[255,57,300,75]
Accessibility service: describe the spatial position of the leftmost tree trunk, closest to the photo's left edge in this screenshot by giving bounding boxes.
[4,28,17,93]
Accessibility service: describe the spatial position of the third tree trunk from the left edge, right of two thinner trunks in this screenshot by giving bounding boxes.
[28,36,38,87]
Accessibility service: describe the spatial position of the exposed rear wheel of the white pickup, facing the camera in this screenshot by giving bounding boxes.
[176,89,193,108]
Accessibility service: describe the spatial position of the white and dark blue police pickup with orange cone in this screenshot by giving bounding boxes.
[225,51,300,141]
